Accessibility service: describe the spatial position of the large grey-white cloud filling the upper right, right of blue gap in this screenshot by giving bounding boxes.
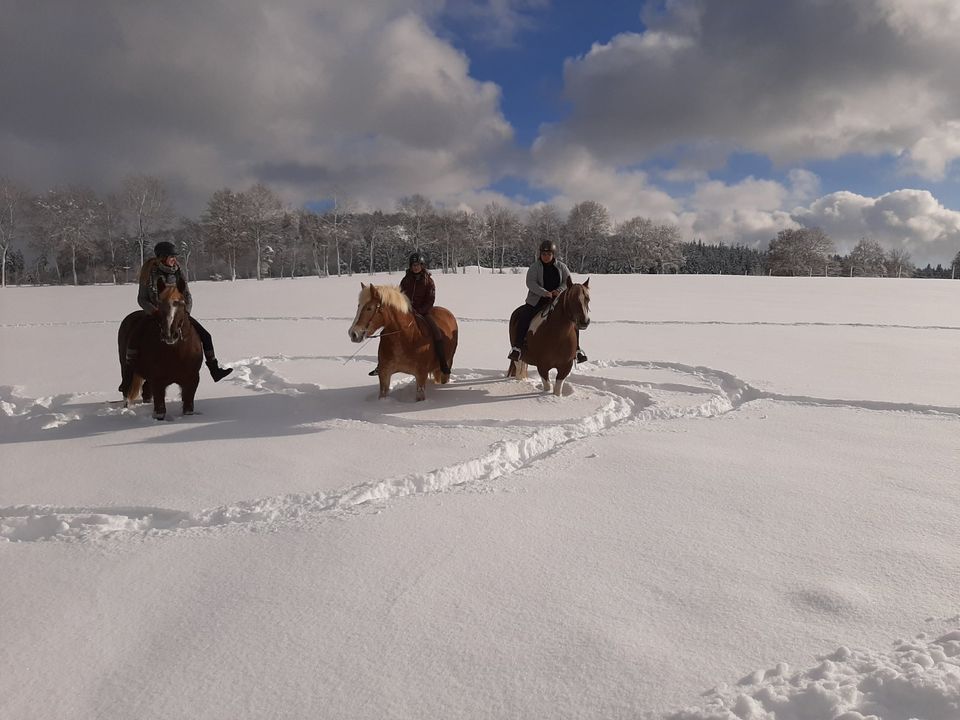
[545,0,960,178]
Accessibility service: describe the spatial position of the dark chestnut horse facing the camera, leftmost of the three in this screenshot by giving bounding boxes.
[117,283,203,420]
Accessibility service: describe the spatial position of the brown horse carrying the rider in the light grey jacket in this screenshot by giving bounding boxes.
[507,278,590,397]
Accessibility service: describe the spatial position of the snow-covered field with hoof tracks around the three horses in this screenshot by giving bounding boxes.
[0,273,960,720]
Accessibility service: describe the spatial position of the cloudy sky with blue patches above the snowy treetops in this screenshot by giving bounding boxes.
[0,0,960,264]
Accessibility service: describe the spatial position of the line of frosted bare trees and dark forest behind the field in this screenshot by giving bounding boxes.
[0,175,960,286]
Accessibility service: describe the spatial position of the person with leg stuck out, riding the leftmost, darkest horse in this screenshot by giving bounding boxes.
[120,240,233,394]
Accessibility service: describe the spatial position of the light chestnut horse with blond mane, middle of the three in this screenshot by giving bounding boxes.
[347,283,459,400]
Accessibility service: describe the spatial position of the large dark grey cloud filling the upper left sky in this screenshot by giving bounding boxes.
[0,0,514,212]
